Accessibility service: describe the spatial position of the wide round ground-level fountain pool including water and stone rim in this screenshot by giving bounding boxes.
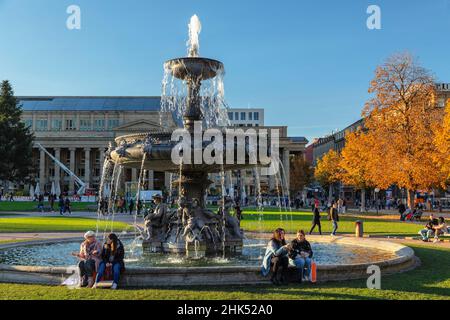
[0,235,418,287]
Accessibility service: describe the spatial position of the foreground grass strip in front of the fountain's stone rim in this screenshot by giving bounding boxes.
[0,246,450,300]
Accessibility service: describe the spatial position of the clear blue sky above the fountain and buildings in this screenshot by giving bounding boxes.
[0,0,450,139]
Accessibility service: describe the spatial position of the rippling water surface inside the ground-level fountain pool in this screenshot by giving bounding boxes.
[0,239,396,267]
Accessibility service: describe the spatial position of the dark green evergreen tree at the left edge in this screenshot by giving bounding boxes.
[0,80,34,189]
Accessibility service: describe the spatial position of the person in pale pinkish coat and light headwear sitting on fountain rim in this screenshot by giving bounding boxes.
[72,231,102,288]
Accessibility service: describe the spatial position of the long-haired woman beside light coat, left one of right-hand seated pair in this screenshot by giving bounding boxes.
[261,228,289,285]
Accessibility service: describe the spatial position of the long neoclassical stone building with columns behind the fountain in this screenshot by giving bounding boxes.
[18,96,308,195]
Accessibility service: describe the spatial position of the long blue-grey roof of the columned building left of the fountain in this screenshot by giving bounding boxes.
[17,97,161,111]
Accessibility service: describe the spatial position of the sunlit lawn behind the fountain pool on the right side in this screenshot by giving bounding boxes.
[241,210,425,236]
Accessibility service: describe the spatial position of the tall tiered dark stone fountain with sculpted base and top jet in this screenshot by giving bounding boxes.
[109,16,255,256]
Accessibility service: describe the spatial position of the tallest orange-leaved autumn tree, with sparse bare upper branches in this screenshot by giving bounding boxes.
[363,54,442,207]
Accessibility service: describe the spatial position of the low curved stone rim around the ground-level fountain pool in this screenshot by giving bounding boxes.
[0,236,420,288]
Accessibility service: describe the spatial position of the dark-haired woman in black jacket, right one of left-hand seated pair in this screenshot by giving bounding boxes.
[93,233,125,290]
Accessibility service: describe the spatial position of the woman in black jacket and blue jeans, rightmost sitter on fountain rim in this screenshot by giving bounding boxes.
[289,230,313,282]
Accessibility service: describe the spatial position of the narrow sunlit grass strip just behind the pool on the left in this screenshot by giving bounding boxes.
[0,217,131,232]
